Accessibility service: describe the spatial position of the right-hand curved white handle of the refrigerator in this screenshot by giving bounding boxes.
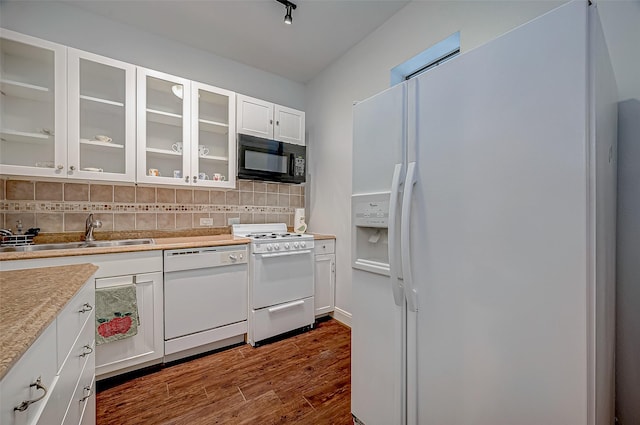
[400,162,418,311]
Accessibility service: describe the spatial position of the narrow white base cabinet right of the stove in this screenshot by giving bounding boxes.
[314,240,336,316]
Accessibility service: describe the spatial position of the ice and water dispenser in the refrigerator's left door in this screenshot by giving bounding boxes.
[351,192,390,276]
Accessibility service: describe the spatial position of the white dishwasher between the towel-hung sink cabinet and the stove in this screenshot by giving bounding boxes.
[164,245,248,363]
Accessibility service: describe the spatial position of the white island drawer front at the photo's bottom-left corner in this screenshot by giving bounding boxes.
[0,322,58,425]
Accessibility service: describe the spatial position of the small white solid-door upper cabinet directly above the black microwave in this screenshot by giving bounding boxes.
[237,95,305,146]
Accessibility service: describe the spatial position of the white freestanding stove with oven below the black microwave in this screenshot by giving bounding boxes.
[233,223,315,347]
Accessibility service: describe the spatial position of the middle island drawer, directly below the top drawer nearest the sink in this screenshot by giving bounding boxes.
[39,311,95,425]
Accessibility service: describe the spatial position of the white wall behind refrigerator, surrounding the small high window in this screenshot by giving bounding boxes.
[306,1,562,320]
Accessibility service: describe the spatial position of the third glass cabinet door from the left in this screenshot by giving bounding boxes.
[137,68,192,185]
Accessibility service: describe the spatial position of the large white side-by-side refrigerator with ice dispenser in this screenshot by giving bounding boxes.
[351,1,617,425]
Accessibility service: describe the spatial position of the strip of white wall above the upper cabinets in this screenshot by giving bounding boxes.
[0,1,305,110]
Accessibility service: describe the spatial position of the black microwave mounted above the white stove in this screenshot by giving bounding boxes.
[238,134,307,183]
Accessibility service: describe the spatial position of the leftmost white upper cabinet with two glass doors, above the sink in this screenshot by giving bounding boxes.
[0,29,136,181]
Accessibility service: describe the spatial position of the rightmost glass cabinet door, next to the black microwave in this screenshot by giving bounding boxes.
[191,82,236,187]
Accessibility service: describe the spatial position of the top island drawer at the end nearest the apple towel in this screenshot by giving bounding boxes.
[57,279,95,370]
